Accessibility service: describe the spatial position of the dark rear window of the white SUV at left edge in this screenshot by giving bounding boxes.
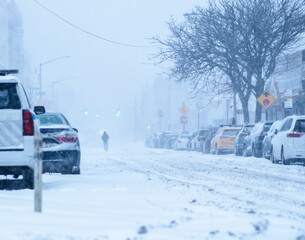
[0,83,21,109]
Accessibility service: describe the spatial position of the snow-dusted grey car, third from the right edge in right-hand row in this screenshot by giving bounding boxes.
[243,121,273,157]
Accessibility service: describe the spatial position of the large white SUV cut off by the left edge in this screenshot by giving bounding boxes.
[0,70,39,188]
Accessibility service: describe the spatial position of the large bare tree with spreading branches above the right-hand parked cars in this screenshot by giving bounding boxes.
[155,0,305,122]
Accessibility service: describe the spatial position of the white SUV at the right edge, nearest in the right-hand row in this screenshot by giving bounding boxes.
[270,115,305,165]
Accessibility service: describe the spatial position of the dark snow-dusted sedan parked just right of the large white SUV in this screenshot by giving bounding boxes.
[37,112,80,174]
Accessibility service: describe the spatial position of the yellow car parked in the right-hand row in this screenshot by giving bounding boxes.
[211,126,241,154]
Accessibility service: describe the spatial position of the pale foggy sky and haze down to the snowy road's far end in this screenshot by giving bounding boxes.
[15,0,205,146]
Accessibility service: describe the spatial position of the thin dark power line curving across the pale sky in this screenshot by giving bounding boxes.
[33,0,153,48]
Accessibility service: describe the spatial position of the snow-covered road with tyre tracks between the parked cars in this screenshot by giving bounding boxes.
[0,144,305,240]
